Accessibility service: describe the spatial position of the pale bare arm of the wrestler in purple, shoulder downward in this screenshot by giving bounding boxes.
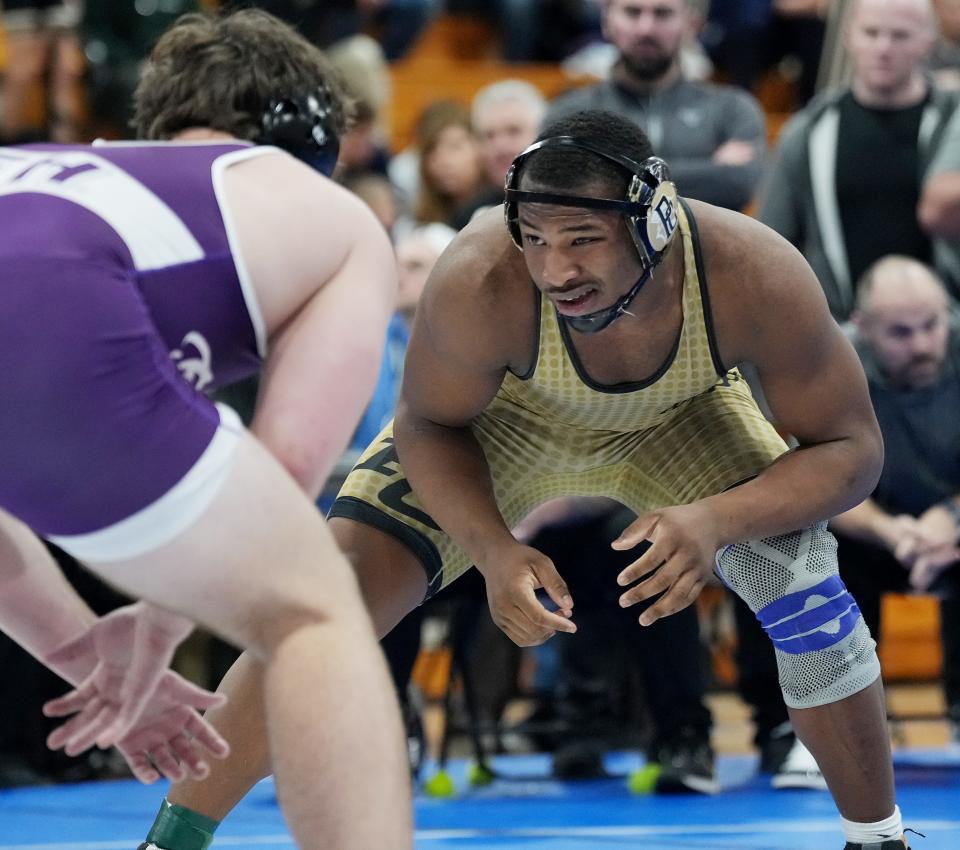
[226,154,397,498]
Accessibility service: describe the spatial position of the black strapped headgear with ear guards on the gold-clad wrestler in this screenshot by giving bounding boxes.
[503,136,679,268]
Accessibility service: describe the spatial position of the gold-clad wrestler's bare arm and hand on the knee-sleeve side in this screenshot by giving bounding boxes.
[614,204,883,624]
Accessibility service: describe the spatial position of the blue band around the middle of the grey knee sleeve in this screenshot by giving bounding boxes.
[757,575,860,655]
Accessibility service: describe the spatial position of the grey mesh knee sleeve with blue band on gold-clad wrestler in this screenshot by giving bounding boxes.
[717,522,880,708]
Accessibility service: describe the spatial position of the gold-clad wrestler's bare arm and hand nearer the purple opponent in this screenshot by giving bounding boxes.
[394,216,575,646]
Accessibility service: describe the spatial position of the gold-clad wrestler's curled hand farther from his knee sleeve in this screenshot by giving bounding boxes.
[477,543,577,646]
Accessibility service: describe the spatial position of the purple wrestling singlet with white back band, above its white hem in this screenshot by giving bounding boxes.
[0,143,275,536]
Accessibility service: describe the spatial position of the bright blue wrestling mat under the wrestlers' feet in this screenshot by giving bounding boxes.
[0,750,960,850]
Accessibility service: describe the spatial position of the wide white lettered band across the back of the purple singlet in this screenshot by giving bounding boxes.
[0,148,204,271]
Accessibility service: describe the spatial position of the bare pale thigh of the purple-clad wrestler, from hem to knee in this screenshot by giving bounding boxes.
[86,432,369,656]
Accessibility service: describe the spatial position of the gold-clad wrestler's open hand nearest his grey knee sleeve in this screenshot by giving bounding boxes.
[610,503,720,626]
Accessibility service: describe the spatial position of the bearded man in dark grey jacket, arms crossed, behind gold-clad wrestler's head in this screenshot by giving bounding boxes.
[547,0,766,210]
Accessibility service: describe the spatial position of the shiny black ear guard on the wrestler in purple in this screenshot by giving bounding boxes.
[257,87,340,177]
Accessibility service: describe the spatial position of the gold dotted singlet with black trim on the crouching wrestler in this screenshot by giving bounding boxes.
[330,200,787,595]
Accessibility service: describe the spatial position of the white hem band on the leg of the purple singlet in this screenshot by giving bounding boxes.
[48,404,244,564]
